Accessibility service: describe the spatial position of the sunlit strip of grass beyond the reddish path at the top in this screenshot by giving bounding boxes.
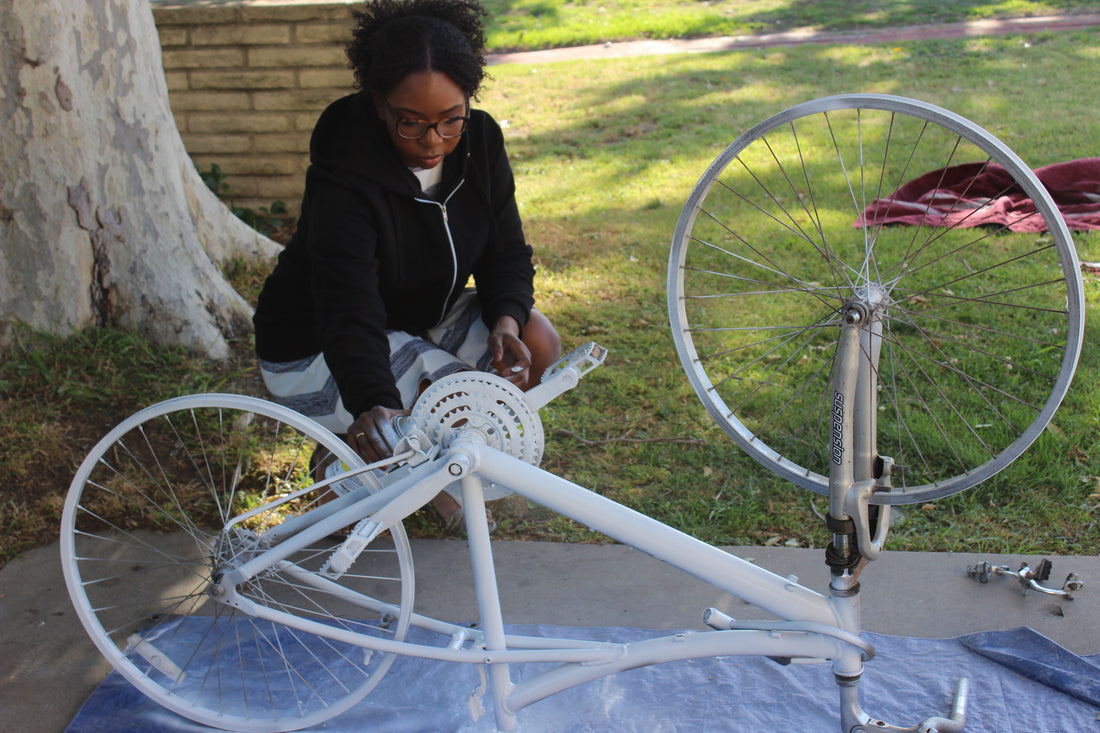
[485,0,1098,52]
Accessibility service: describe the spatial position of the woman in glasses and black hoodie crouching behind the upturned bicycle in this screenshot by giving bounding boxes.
[254,0,560,524]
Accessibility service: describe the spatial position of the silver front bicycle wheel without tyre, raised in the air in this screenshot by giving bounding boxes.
[668,95,1084,504]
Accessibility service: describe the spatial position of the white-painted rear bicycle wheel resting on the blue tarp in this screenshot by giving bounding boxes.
[61,395,413,731]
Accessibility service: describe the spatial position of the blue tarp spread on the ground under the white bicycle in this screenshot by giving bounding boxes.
[67,626,1100,733]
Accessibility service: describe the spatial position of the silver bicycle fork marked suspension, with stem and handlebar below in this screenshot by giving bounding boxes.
[826,299,969,733]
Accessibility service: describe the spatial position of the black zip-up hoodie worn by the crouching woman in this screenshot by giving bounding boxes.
[253,91,535,417]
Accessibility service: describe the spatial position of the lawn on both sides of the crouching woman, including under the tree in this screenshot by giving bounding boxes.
[0,11,1100,562]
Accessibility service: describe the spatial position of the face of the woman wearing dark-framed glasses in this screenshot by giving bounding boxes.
[374,72,468,168]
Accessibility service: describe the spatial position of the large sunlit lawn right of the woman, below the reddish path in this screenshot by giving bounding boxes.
[483,33,1100,553]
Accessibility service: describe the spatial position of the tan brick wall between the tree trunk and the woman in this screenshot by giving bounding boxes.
[153,0,361,212]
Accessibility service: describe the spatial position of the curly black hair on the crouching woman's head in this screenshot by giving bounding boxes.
[347,0,487,97]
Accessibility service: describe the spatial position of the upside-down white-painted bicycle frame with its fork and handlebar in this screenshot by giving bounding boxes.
[210,302,967,733]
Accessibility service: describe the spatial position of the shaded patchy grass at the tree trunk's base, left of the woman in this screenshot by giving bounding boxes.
[0,327,255,564]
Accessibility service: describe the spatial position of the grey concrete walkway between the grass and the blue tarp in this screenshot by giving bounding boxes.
[0,540,1100,733]
